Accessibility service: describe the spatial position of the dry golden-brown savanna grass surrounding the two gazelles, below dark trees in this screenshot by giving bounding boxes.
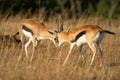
[0,16,120,80]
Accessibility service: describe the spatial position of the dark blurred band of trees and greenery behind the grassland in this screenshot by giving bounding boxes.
[0,0,120,20]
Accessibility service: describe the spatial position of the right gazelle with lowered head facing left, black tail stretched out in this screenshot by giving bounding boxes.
[57,18,115,65]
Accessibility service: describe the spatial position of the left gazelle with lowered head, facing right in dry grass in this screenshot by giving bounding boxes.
[14,19,56,60]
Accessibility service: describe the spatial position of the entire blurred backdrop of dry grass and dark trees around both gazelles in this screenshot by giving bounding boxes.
[0,0,120,80]
